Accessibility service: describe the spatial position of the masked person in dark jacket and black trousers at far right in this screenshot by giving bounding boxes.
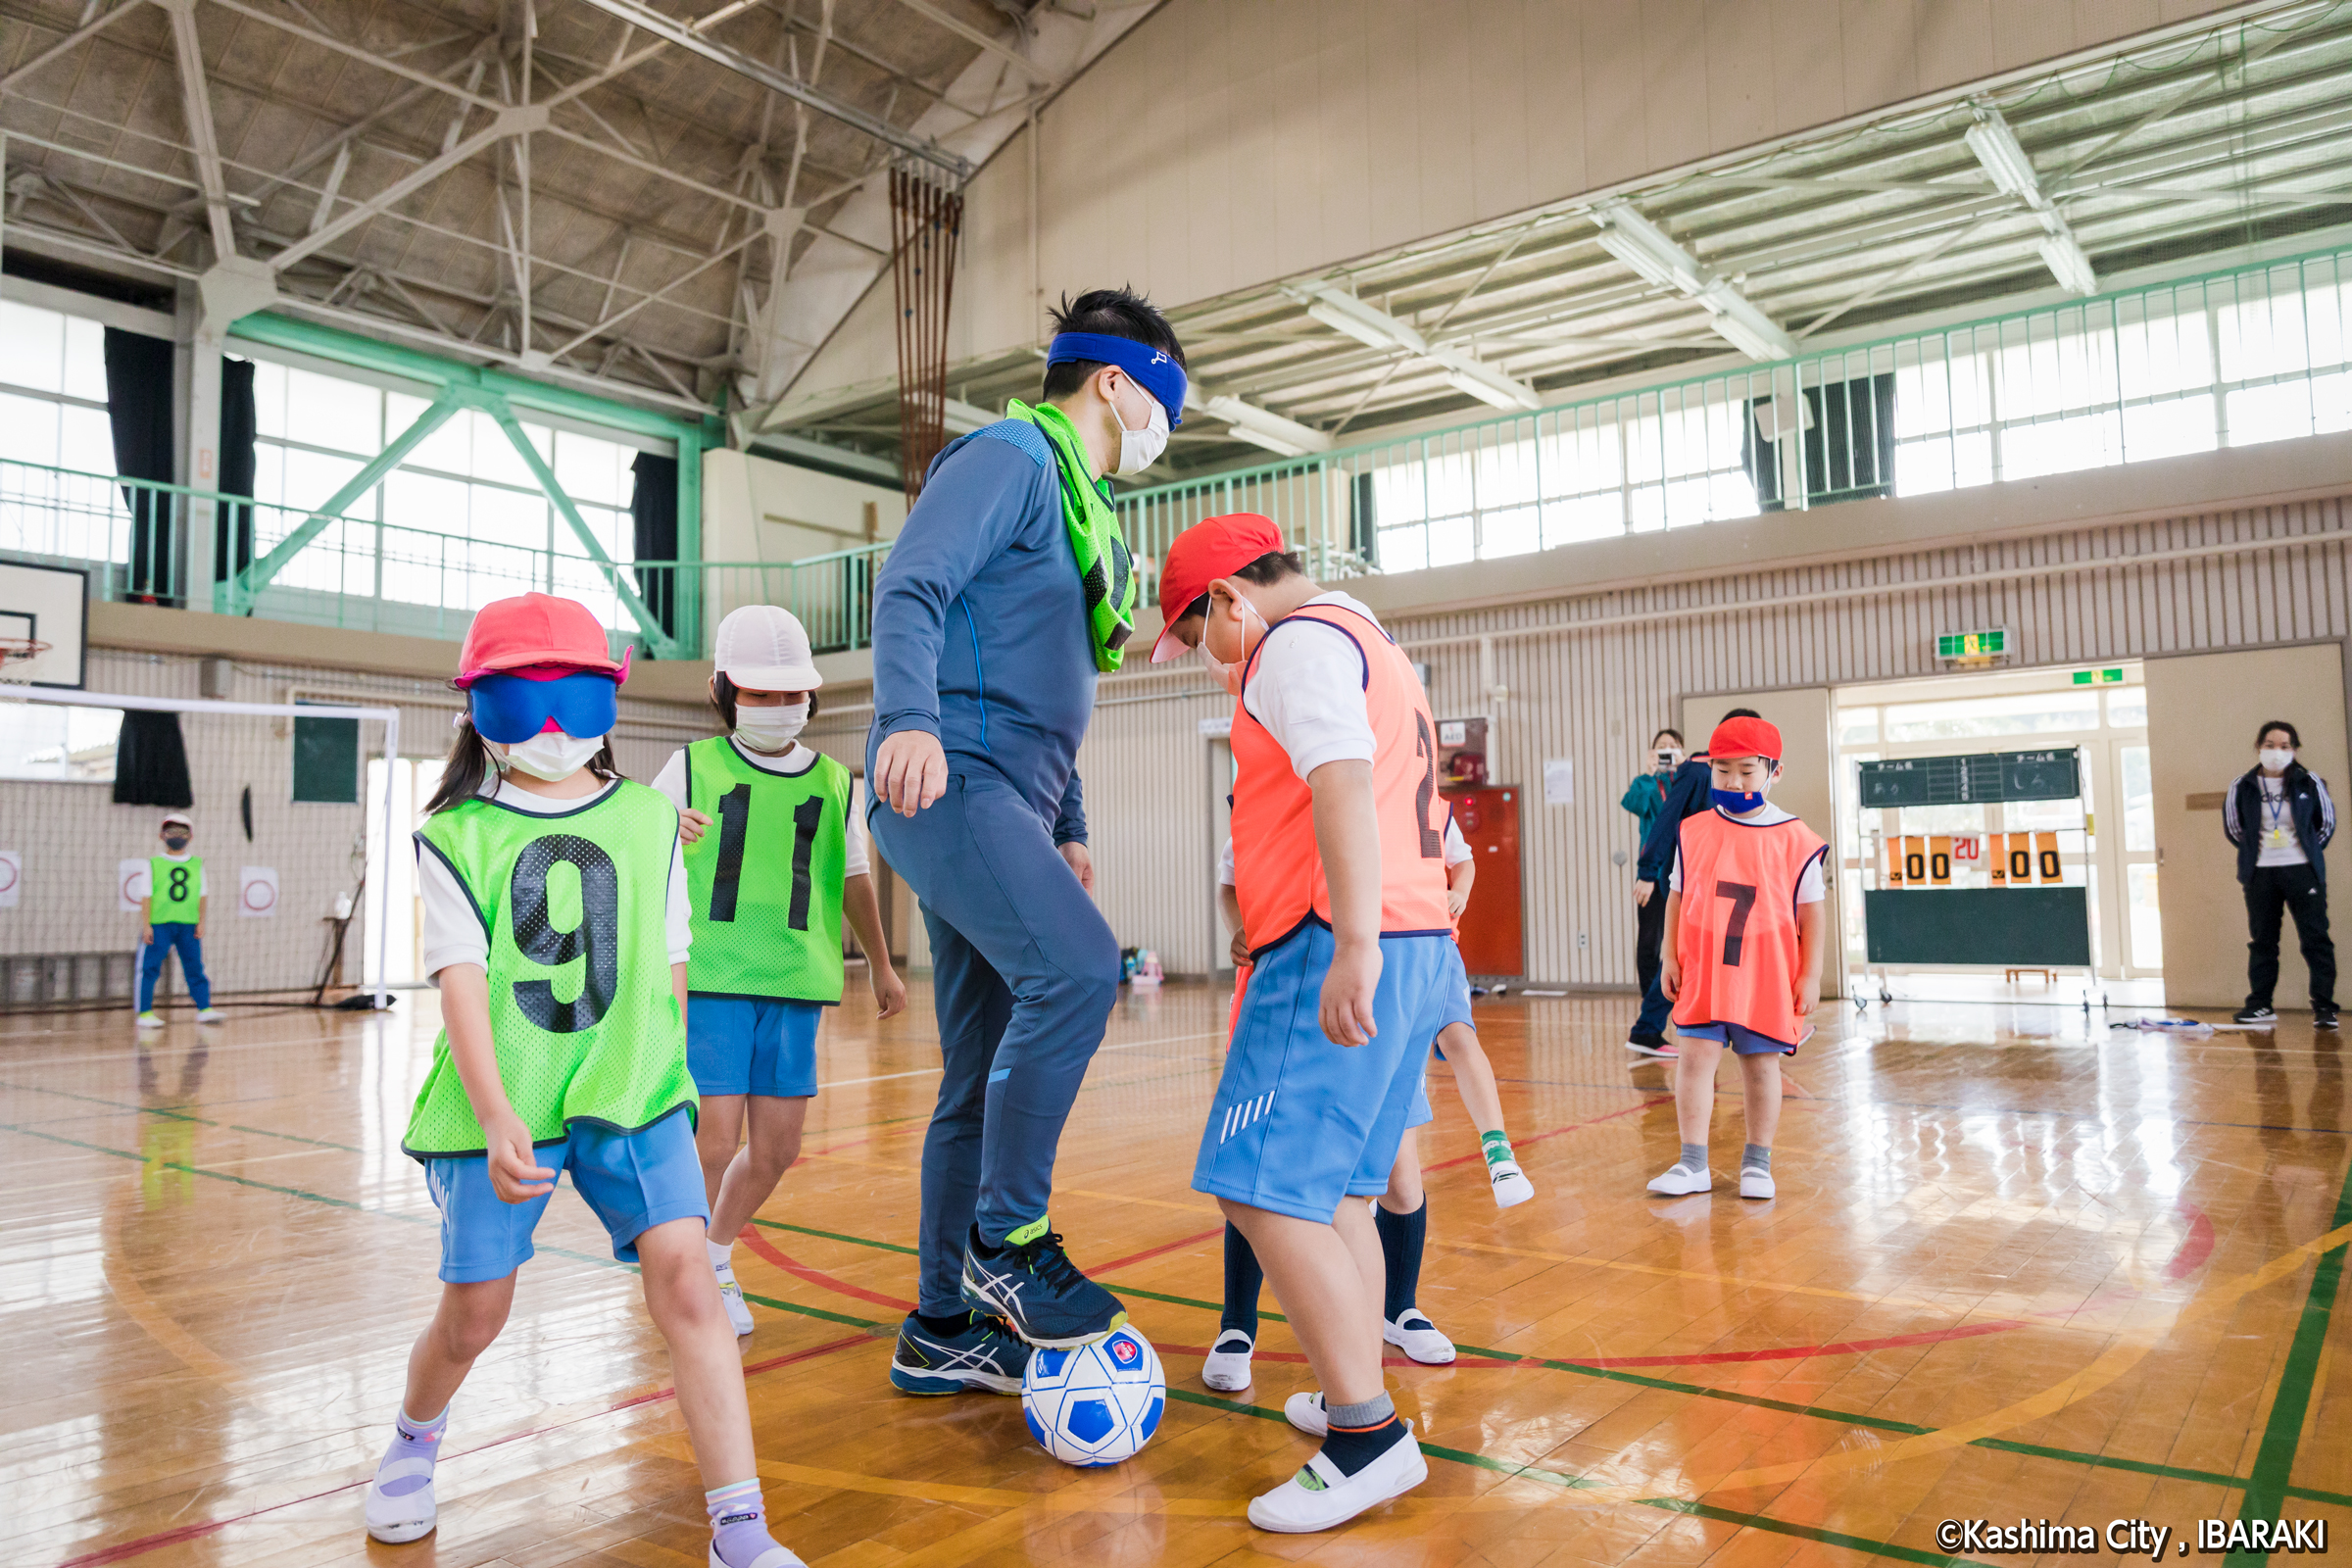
[2221,719,2335,1030]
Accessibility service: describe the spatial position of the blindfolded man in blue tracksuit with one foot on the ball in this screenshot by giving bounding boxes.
[865,289,1186,1394]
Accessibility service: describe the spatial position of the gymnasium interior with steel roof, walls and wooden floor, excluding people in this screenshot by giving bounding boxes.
[0,0,2352,1568]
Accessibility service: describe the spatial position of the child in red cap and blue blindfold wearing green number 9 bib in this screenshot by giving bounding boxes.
[367,592,800,1568]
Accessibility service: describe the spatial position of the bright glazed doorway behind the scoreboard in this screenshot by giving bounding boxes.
[1833,661,2164,1006]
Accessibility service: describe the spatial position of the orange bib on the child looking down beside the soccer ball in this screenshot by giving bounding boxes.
[1233,604,1453,953]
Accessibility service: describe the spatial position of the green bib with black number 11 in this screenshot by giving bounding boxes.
[687,736,849,1002]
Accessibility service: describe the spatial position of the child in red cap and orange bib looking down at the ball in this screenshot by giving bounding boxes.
[1152,513,1470,1533]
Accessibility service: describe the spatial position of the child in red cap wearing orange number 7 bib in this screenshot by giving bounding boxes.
[1648,717,1830,1199]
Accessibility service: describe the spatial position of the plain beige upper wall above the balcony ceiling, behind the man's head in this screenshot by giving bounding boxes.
[793,0,2225,393]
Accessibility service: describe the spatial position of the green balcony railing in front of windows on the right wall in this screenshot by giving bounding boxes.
[1119,236,2352,571]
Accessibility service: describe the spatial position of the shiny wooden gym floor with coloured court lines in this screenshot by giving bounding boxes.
[14,985,2352,1568]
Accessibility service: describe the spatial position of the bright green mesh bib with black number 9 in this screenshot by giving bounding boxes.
[400,780,699,1159]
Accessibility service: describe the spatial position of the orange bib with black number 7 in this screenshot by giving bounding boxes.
[1675,811,1830,1044]
